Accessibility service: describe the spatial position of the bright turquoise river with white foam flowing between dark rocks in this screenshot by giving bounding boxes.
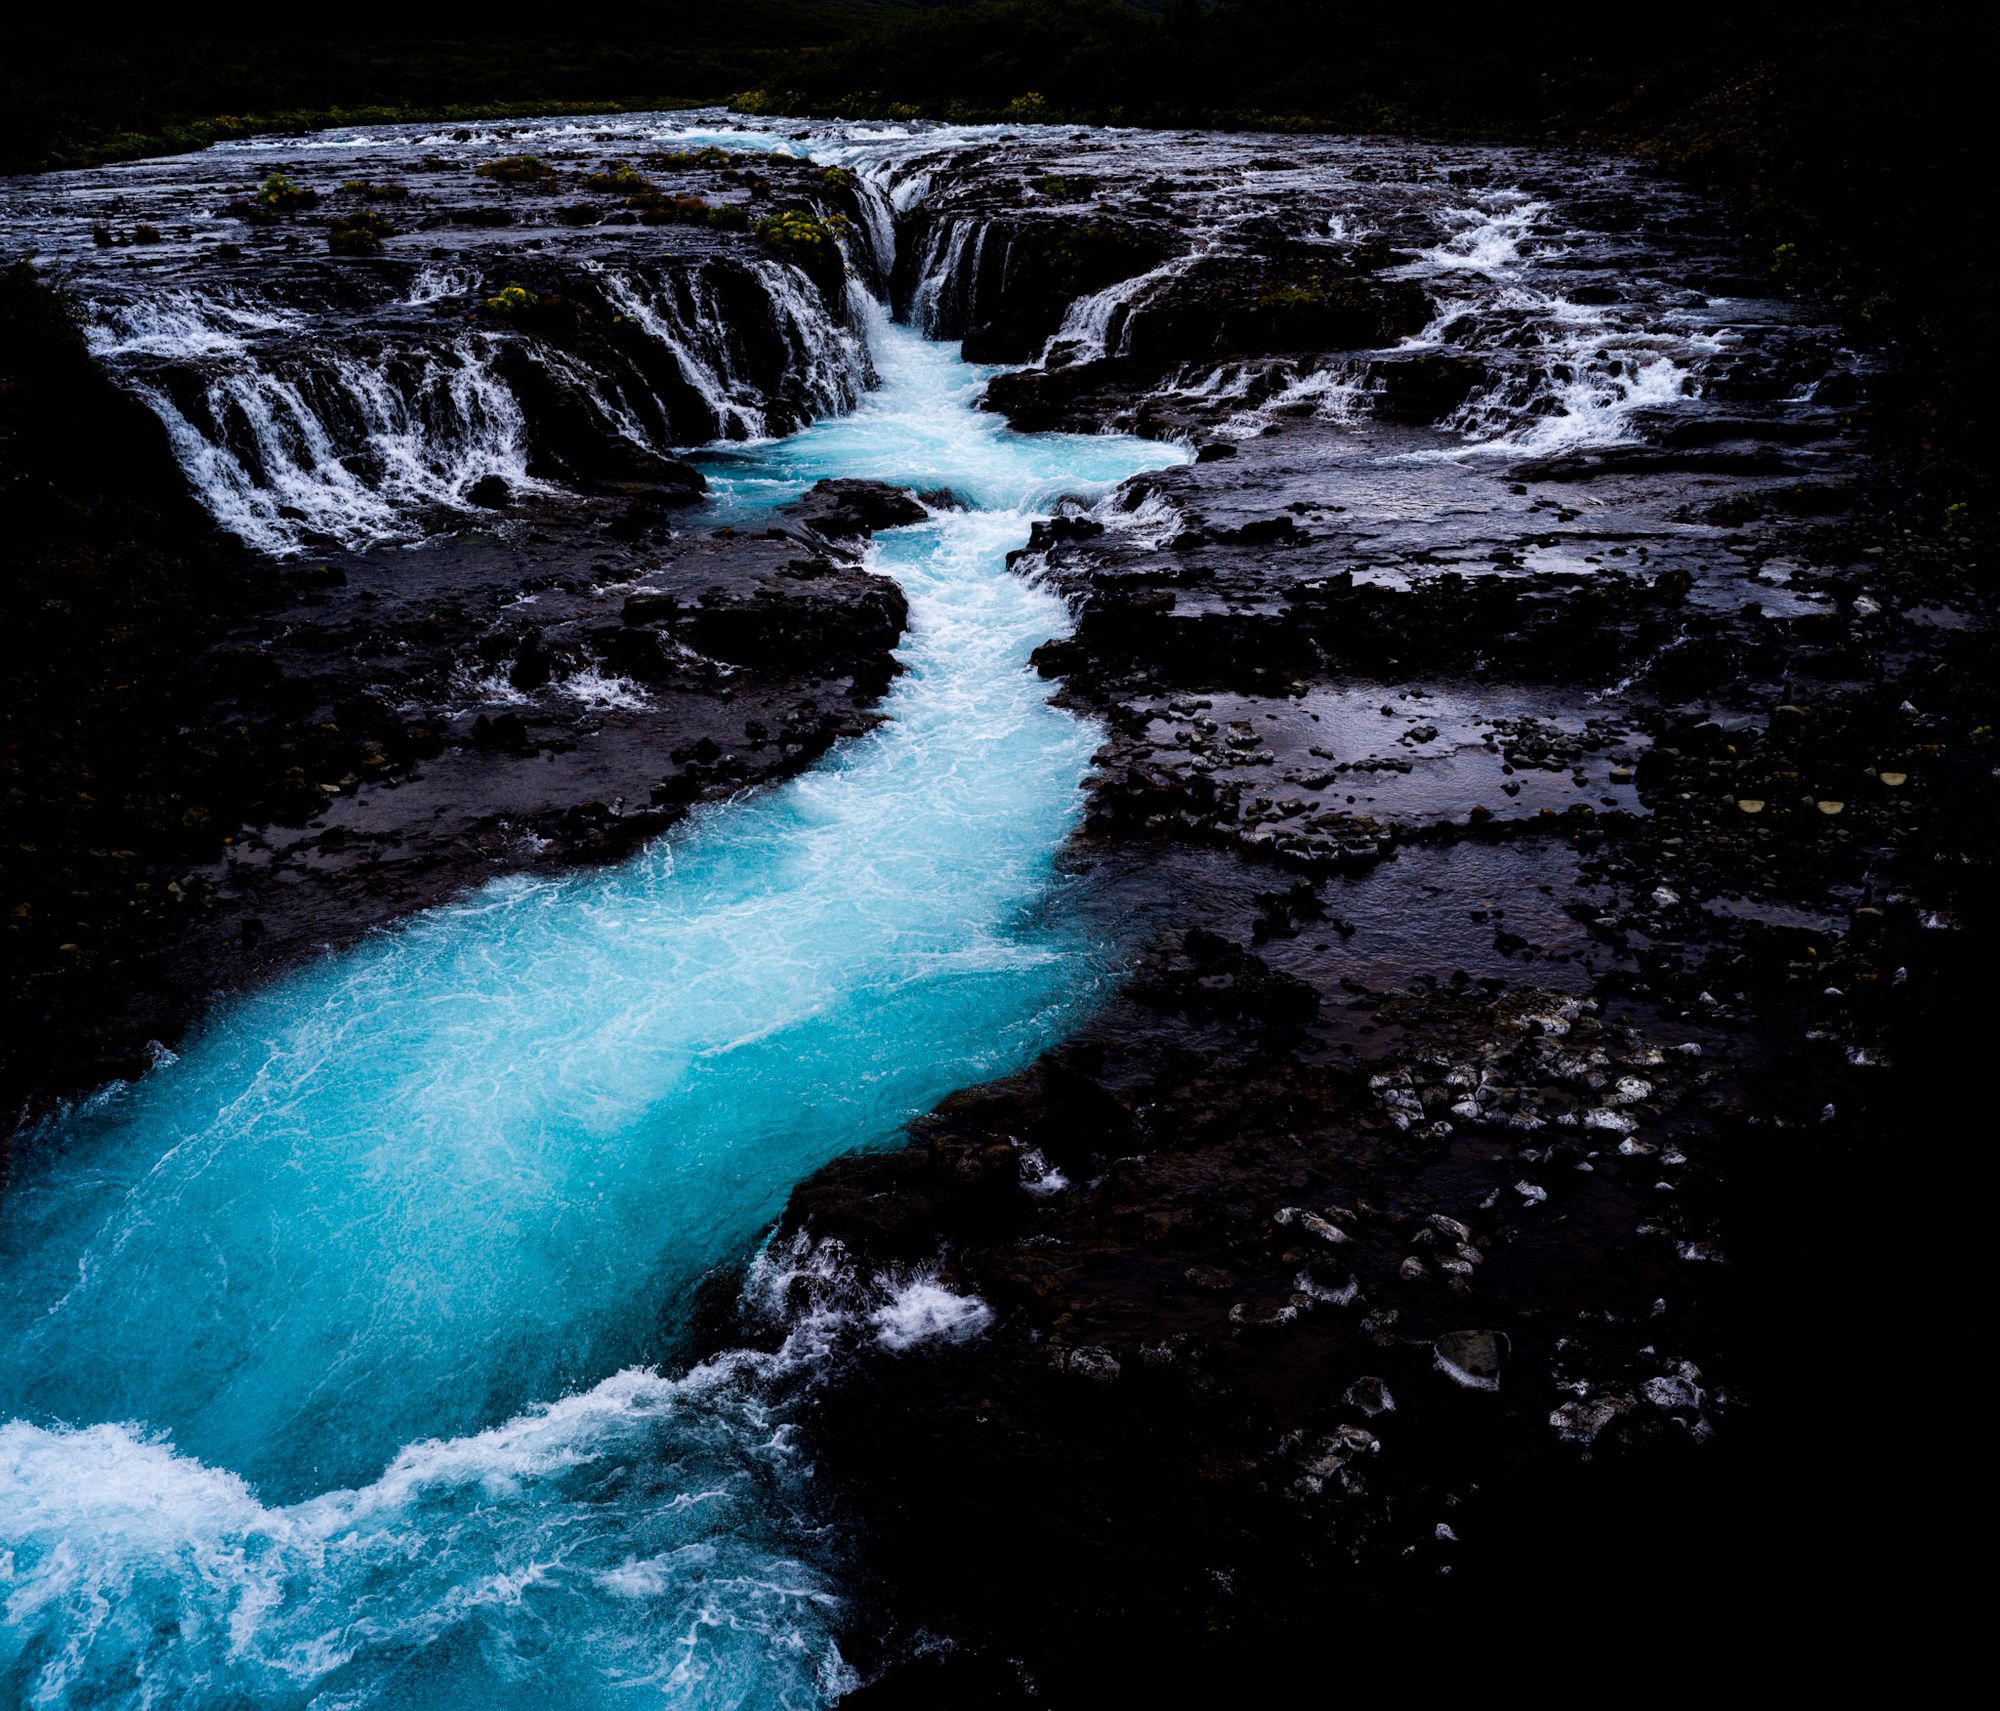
[0,299,1178,1711]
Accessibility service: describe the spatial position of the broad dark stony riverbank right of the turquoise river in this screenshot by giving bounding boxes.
[752,126,1994,1705]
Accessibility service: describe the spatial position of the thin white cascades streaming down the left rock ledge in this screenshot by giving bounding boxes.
[88,258,874,554]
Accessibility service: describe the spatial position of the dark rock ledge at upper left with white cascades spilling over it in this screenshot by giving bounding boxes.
[0,137,882,554]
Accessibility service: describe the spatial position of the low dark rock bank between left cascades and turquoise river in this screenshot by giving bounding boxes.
[8,467,914,1097]
